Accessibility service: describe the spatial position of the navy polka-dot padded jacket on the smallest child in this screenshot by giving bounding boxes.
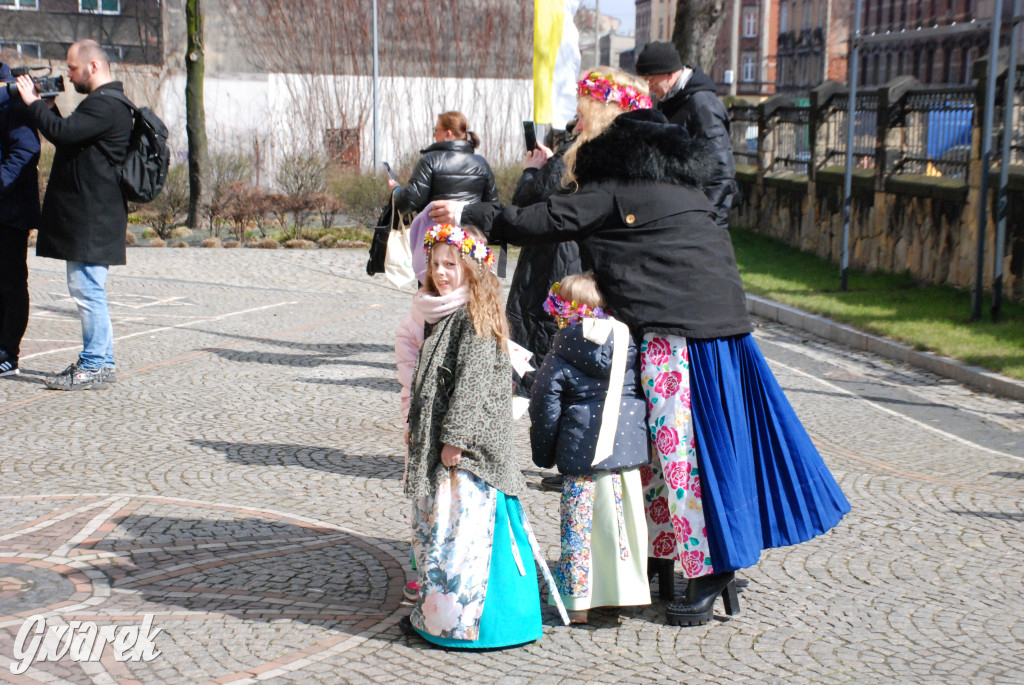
[529,324,650,476]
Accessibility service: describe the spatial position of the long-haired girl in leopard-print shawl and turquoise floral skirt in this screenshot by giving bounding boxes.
[403,224,565,649]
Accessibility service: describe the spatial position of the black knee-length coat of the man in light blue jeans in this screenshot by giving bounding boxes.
[30,81,132,265]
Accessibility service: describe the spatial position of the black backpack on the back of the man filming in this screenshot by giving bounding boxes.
[102,90,171,203]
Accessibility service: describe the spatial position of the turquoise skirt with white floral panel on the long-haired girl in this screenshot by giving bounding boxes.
[410,469,543,649]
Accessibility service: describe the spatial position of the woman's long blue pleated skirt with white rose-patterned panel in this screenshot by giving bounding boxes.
[641,334,850,577]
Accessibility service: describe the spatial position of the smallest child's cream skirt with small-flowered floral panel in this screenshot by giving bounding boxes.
[555,469,650,611]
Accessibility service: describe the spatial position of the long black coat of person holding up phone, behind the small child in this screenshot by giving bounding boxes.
[505,145,582,368]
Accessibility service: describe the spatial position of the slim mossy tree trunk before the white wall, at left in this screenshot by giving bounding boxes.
[185,0,207,228]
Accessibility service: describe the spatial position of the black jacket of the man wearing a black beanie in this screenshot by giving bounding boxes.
[657,68,736,228]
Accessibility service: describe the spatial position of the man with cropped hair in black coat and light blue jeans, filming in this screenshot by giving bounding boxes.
[17,39,132,390]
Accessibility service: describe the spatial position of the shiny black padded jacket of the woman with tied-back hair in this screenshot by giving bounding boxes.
[394,140,498,212]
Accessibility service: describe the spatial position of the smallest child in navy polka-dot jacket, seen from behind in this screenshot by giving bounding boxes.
[529,272,650,623]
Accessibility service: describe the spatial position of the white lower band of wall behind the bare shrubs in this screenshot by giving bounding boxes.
[158,73,532,183]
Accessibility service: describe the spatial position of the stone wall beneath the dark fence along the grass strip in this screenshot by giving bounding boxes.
[732,170,1024,301]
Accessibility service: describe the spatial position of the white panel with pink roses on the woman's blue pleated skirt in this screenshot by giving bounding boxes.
[640,334,715,577]
